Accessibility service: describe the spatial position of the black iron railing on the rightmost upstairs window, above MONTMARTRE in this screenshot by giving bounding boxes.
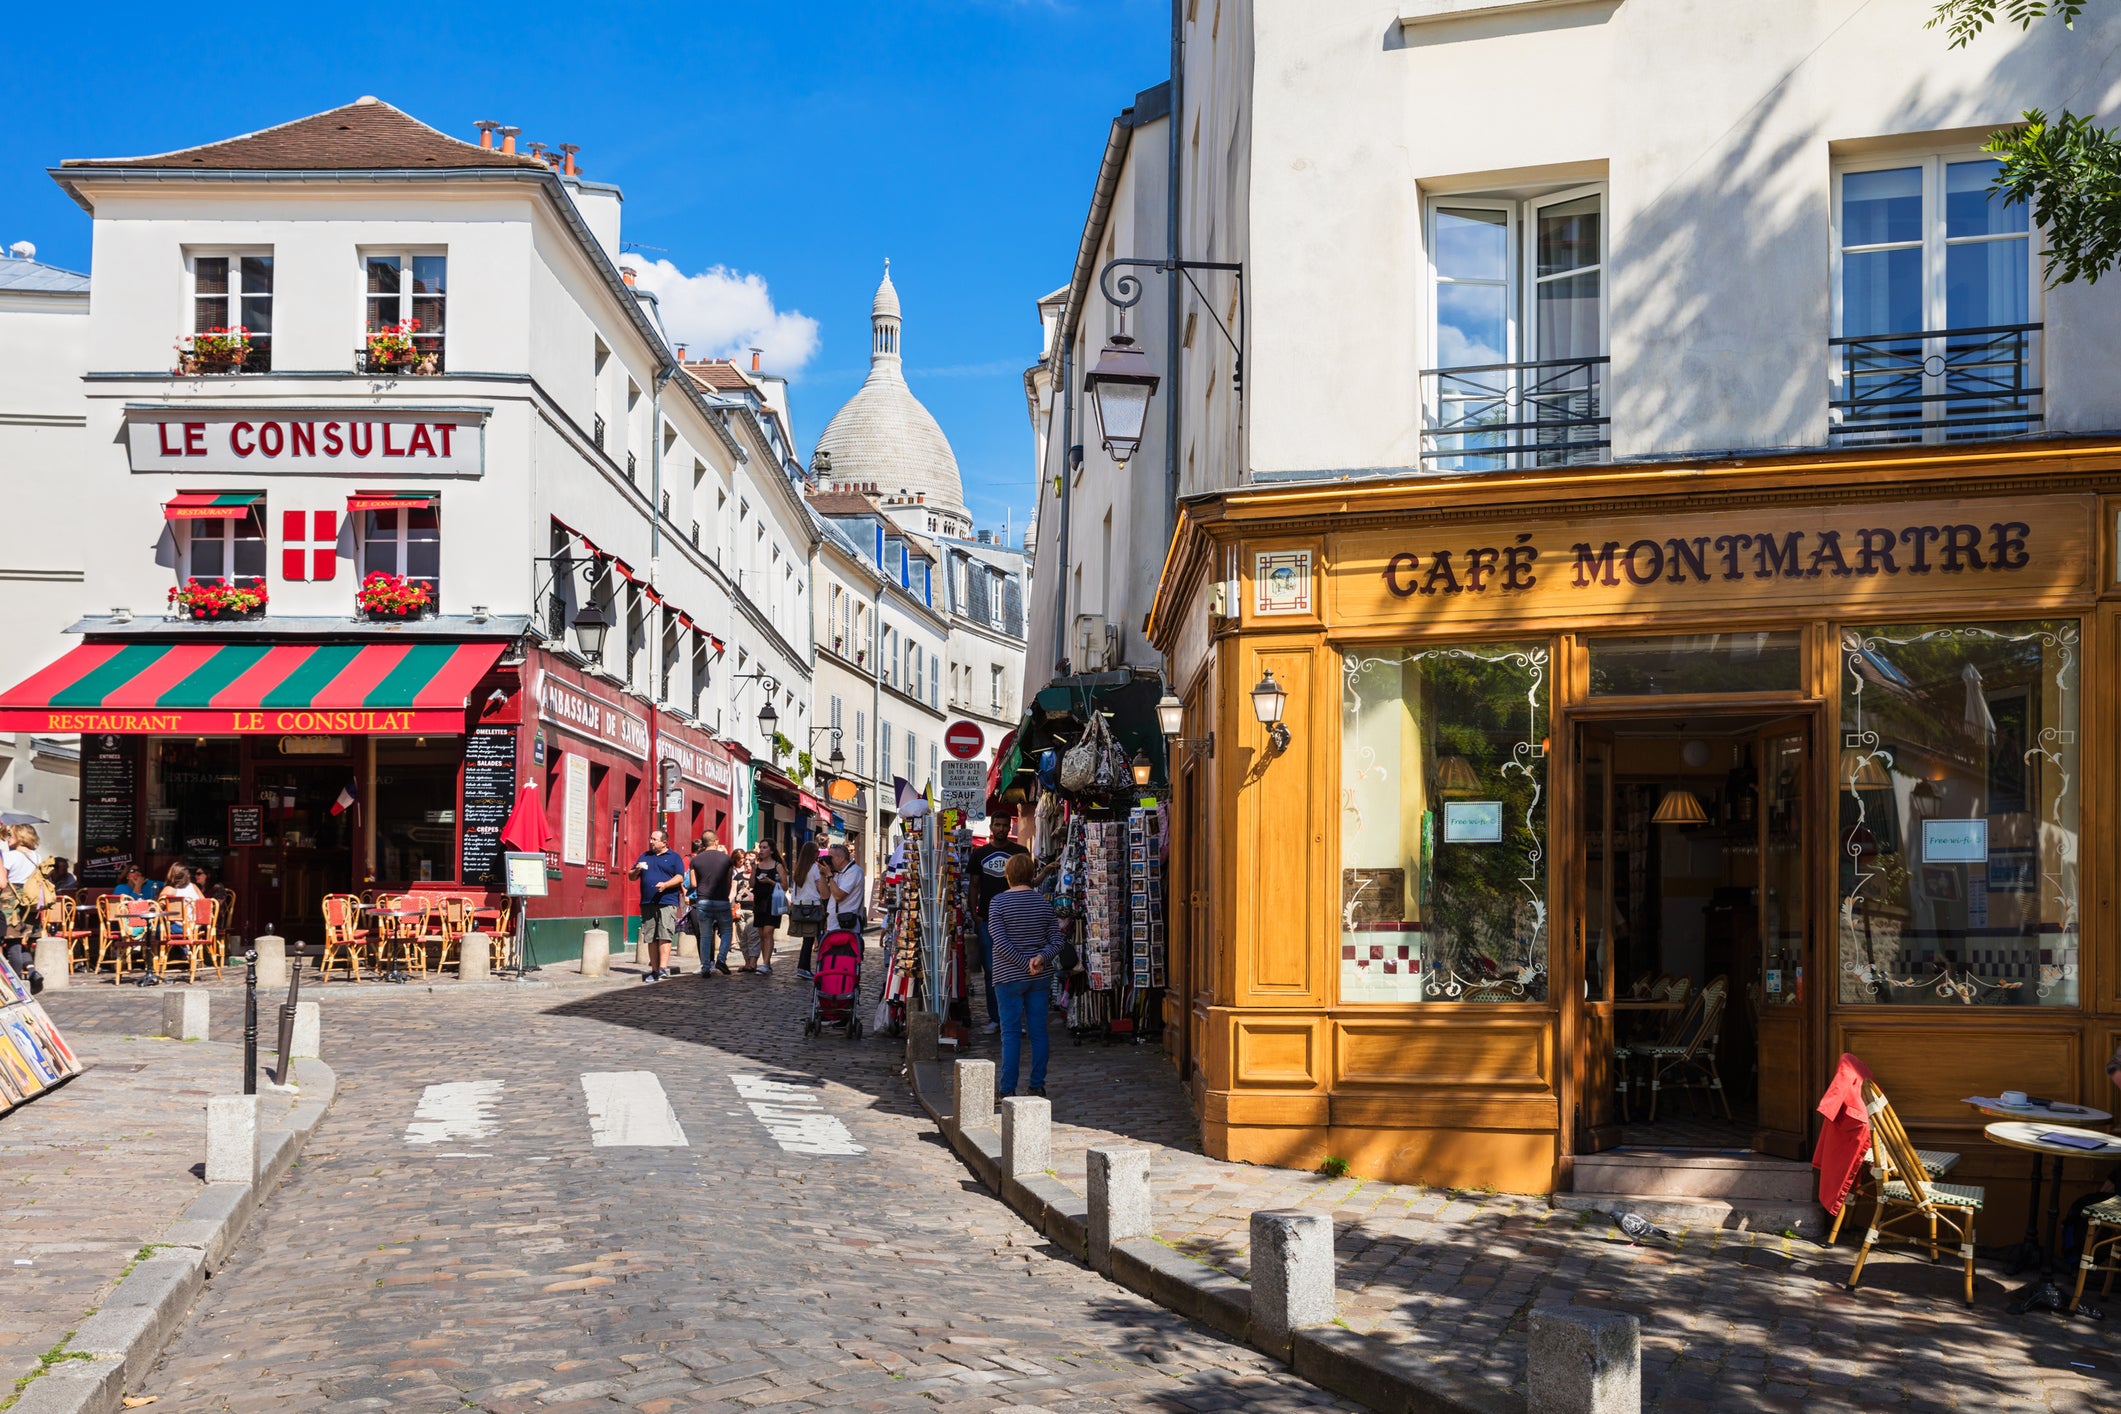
[1826,324,2045,447]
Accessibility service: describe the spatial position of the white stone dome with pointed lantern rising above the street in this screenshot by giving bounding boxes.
[817,261,965,515]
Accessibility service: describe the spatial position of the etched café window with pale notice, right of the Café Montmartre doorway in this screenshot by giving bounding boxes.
[1835,619,2085,1007]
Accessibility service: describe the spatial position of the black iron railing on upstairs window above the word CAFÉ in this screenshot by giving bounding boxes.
[1421,354,1612,471]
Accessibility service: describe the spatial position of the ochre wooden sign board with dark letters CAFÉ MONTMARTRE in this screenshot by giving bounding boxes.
[1328,496,2093,621]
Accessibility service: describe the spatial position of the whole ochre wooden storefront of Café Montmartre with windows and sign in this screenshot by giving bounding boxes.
[1150,441,2121,1232]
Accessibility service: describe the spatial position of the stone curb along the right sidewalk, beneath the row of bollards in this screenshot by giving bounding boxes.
[908,1060,1525,1414]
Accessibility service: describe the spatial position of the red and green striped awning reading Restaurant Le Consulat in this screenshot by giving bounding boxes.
[0,642,505,736]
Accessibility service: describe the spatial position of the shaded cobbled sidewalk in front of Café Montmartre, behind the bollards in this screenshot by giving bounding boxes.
[1001,1039,2121,1414]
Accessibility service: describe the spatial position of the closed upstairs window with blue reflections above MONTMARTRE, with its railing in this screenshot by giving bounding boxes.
[1830,151,2043,445]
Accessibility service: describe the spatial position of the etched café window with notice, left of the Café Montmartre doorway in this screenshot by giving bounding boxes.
[1340,644,1548,1003]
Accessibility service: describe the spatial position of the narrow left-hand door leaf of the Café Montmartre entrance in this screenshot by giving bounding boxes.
[1574,725,1620,1153]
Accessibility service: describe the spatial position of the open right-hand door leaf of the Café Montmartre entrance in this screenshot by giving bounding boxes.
[1733,717,1824,1157]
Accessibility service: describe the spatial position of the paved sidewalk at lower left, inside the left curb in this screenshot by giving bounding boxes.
[0,1021,299,1403]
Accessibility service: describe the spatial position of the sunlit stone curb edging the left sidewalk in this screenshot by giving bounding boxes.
[6,1060,339,1414]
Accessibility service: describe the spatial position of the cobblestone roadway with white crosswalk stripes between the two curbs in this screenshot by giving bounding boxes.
[41,952,1349,1414]
